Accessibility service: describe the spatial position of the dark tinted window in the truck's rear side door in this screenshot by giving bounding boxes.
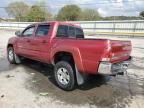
[36,25,50,36]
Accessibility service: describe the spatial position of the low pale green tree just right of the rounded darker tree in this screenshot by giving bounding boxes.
[79,9,101,21]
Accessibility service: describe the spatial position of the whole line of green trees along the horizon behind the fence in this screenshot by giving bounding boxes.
[5,2,144,22]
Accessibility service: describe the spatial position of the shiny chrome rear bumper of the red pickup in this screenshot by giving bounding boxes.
[98,57,131,75]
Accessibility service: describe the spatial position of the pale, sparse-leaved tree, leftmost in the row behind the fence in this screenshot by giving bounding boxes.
[5,2,29,21]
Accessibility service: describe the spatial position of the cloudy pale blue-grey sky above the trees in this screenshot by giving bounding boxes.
[0,0,144,17]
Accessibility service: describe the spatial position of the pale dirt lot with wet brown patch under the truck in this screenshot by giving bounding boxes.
[0,30,144,108]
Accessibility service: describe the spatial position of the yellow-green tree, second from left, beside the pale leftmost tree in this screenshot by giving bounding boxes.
[27,5,51,22]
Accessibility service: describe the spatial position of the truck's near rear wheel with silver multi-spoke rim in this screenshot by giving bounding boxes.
[54,61,76,91]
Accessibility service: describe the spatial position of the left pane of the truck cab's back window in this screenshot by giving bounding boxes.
[57,25,68,37]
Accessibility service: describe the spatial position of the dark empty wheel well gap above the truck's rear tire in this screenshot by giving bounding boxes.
[54,52,74,65]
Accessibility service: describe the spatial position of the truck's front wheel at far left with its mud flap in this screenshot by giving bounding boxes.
[7,47,21,64]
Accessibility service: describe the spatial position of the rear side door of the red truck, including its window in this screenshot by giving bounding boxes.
[28,24,50,62]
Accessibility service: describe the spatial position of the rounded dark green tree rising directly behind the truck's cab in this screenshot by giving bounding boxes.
[56,5,81,21]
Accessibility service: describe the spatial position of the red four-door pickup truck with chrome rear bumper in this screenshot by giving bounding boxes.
[7,21,132,90]
